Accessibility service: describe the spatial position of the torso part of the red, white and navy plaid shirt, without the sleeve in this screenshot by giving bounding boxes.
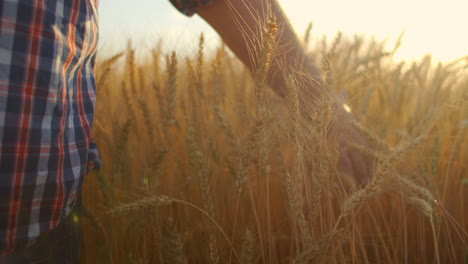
[0,0,98,254]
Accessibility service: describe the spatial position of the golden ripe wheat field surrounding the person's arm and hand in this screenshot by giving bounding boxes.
[80,24,468,263]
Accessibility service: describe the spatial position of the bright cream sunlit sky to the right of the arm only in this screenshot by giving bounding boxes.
[279,0,468,61]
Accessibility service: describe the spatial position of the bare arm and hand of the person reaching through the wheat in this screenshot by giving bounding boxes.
[198,0,374,183]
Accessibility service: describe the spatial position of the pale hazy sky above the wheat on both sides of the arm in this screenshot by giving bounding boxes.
[99,0,468,61]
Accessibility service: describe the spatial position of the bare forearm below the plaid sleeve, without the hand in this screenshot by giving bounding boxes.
[198,0,323,106]
